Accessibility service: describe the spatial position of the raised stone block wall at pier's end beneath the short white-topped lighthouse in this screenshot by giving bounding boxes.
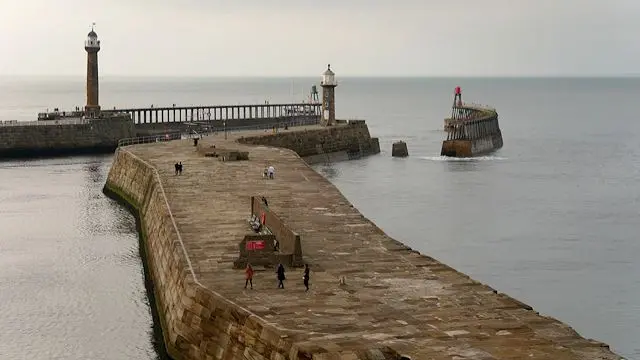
[238,120,380,157]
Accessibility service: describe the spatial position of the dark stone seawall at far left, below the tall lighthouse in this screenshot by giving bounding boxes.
[0,116,134,157]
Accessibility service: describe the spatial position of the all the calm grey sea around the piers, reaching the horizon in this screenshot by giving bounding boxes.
[0,77,640,359]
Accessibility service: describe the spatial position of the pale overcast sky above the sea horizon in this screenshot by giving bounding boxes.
[0,0,640,77]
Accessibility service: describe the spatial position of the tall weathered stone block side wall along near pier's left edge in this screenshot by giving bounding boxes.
[105,150,311,360]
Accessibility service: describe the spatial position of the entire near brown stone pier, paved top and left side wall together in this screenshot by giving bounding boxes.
[105,119,620,359]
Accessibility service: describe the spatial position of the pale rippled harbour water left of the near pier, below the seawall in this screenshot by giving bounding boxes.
[0,156,162,360]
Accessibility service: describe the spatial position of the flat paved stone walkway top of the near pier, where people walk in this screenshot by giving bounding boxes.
[124,127,619,360]
